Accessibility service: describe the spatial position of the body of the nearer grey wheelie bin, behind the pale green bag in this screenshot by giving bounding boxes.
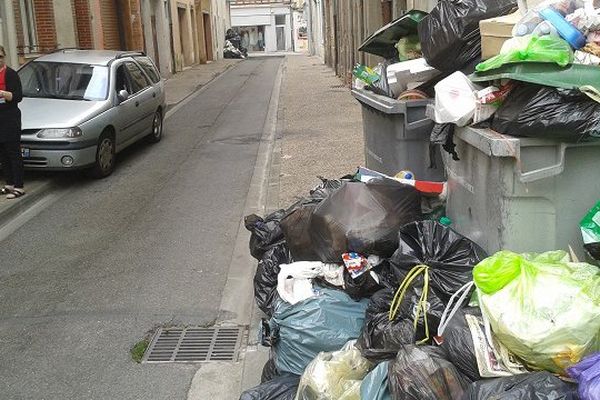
[443,127,600,261]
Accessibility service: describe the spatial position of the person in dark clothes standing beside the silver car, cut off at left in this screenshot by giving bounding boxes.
[0,46,25,199]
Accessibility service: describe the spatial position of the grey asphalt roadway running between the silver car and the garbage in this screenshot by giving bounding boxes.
[0,58,282,400]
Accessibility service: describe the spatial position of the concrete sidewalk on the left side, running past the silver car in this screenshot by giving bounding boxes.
[0,60,242,227]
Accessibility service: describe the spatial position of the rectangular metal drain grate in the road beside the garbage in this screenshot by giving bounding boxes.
[142,326,246,363]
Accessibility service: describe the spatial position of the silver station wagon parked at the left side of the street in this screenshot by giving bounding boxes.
[18,50,166,178]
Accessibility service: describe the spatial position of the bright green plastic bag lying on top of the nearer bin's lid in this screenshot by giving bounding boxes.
[475,35,573,72]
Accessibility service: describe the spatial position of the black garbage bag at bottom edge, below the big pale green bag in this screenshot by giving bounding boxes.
[463,371,579,400]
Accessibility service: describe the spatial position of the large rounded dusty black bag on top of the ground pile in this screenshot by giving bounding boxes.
[309,180,422,262]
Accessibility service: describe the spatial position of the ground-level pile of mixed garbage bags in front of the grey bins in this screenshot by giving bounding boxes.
[240,175,600,400]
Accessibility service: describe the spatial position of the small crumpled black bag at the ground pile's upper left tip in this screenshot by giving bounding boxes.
[244,210,286,261]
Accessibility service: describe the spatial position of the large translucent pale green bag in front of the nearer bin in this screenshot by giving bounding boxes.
[473,251,600,374]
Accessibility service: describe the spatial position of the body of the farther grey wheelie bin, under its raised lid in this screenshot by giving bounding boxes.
[352,89,445,181]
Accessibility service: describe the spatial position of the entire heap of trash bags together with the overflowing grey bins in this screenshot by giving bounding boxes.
[241,0,600,400]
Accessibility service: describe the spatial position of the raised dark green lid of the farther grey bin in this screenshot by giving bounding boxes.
[358,10,428,60]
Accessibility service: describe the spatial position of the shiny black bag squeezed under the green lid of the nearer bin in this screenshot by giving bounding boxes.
[492,83,600,143]
